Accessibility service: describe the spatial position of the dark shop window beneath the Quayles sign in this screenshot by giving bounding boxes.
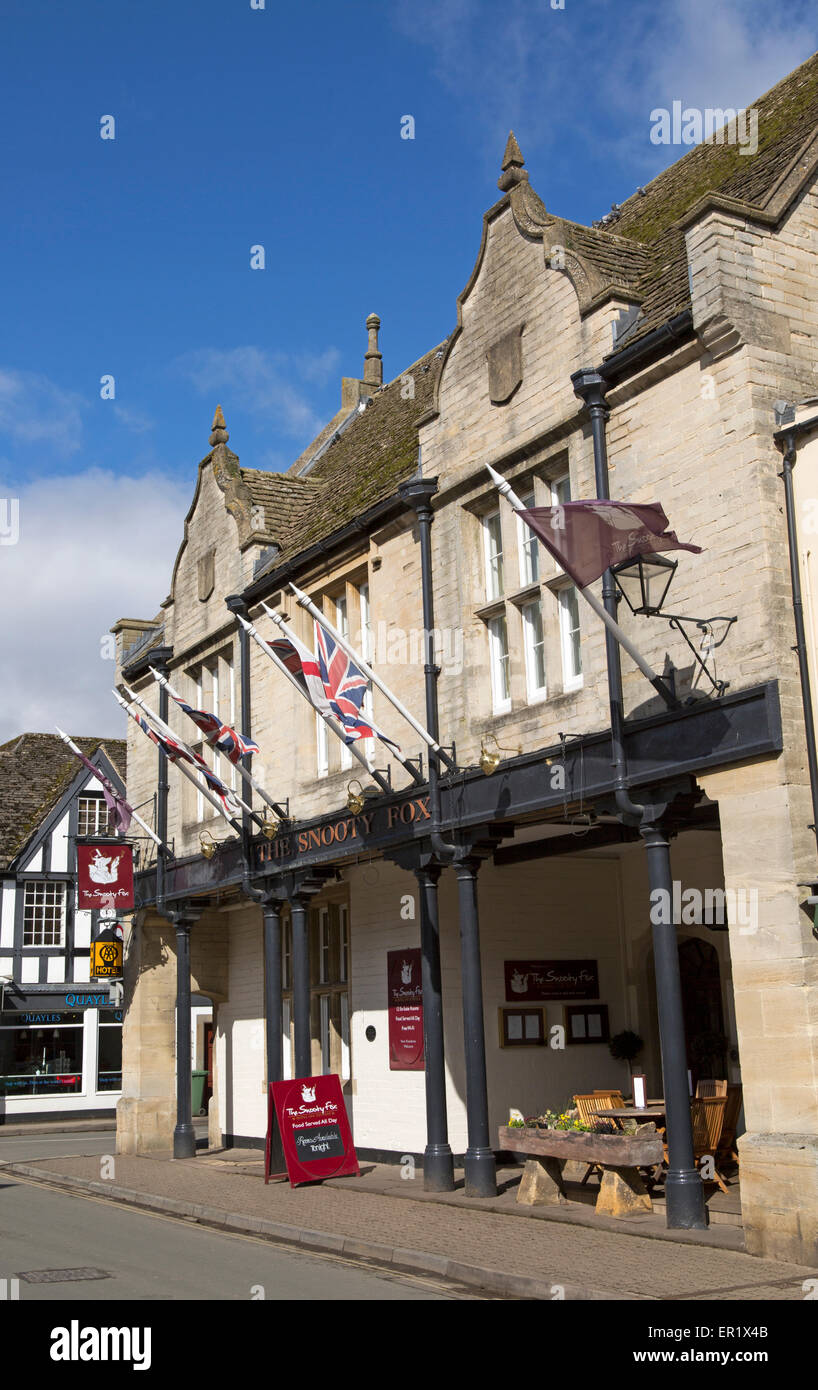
[0,1013,83,1097]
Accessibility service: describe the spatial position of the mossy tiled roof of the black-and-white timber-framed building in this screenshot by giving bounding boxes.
[0,734,127,869]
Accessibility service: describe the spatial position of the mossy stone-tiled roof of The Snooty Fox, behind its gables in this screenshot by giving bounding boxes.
[197,54,818,574]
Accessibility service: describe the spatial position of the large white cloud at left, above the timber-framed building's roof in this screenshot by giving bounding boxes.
[0,468,192,741]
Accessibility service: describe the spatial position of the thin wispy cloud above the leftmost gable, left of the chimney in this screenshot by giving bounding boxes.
[174,346,339,438]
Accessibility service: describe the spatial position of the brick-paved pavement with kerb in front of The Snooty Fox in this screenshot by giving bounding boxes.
[0,1150,818,1301]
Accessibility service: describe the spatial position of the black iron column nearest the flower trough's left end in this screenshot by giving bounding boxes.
[455,855,497,1197]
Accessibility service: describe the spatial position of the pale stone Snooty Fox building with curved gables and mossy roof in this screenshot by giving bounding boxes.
[114,57,818,1262]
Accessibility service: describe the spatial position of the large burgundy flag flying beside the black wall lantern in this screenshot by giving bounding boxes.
[518,499,701,589]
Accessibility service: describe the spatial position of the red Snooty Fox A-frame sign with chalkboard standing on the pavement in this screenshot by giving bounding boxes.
[264,1072,359,1187]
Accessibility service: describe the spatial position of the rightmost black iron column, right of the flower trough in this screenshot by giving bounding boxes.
[640,821,707,1230]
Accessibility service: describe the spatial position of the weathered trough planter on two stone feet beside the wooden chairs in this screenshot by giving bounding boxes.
[498,1125,662,1216]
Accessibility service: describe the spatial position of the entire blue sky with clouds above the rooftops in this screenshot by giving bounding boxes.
[0,0,818,738]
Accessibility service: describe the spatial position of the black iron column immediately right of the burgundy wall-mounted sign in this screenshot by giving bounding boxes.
[415,863,455,1193]
